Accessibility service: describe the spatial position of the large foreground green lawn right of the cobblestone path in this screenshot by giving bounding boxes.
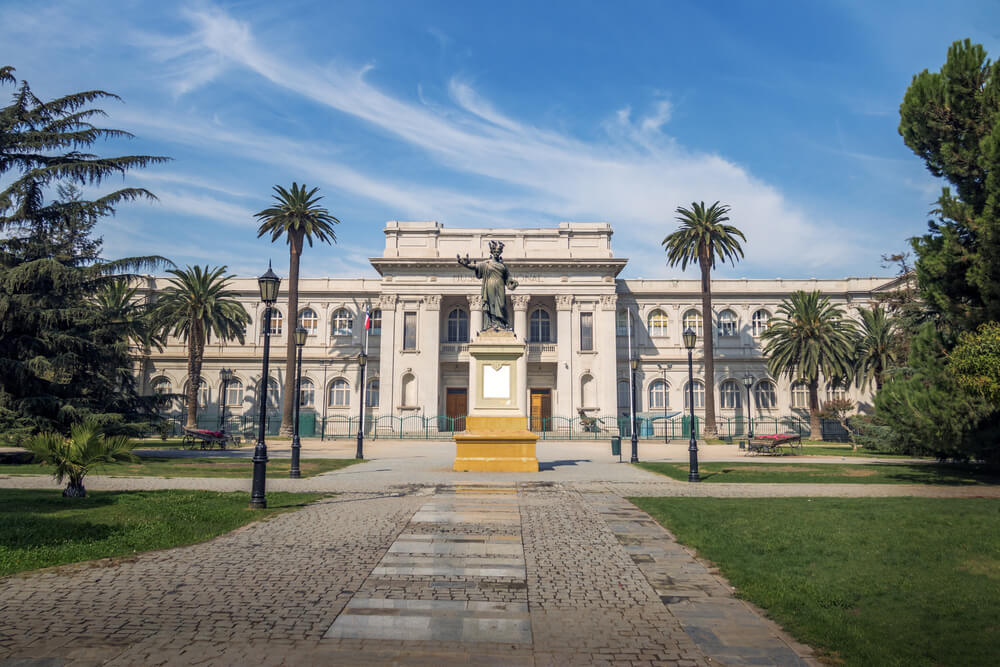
[630,498,1000,666]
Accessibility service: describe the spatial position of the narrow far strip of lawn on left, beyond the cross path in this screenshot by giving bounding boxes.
[0,456,358,484]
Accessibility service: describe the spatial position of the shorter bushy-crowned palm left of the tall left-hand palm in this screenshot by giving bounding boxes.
[153,266,249,428]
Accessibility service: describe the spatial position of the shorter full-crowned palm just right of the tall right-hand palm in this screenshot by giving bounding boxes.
[761,290,857,440]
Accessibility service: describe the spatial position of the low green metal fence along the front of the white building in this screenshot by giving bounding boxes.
[146,412,850,442]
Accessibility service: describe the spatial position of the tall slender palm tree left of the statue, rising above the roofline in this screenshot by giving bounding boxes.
[254,183,340,435]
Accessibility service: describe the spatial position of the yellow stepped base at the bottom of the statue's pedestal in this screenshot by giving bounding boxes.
[453,416,538,472]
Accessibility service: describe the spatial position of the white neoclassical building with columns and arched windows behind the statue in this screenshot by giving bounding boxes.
[140,221,894,436]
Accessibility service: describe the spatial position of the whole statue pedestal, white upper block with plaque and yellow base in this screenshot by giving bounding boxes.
[453,331,538,472]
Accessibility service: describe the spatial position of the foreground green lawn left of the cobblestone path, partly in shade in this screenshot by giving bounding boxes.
[0,482,325,576]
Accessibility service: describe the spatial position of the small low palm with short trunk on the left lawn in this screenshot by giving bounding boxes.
[24,418,139,498]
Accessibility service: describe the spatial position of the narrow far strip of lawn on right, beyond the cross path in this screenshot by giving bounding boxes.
[636,457,1000,486]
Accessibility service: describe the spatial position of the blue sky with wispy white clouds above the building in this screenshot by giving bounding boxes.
[0,0,1000,278]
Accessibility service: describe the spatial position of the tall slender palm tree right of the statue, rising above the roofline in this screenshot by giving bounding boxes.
[663,202,747,438]
